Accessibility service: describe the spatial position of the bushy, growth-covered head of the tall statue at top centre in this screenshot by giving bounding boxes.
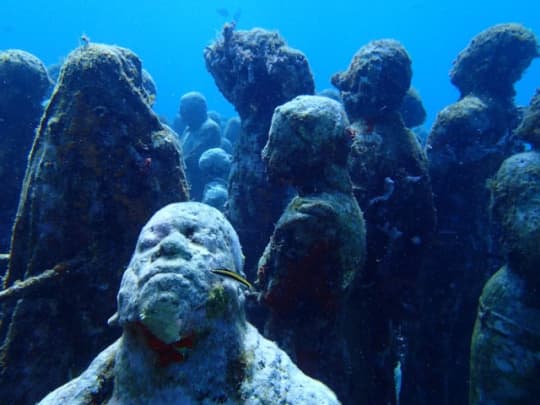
[204,24,314,120]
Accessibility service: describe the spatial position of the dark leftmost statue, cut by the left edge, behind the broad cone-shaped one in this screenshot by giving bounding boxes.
[0,49,52,253]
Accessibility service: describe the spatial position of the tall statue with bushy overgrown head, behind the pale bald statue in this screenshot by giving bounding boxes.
[204,24,314,274]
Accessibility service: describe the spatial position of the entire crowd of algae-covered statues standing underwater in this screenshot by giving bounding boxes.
[0,24,540,404]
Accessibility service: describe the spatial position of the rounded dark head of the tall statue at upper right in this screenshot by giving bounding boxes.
[450,24,539,98]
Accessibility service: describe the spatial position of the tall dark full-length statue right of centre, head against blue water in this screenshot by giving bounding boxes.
[332,39,435,404]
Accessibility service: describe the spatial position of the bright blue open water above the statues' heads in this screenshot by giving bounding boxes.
[0,0,540,126]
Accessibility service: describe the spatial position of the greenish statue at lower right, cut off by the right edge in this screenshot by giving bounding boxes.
[469,150,540,405]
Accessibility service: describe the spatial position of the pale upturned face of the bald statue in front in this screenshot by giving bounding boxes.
[118,203,247,344]
